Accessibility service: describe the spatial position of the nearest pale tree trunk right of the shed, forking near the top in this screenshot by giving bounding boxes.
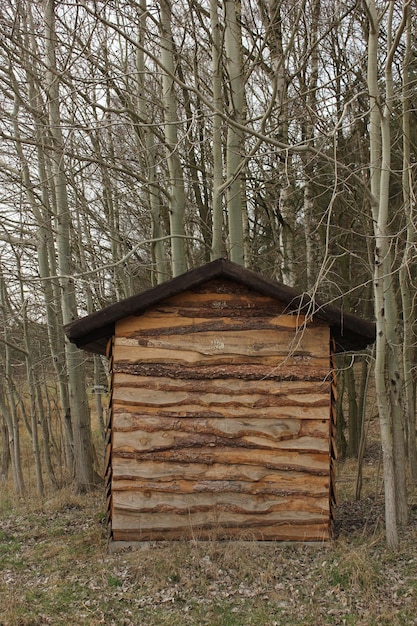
[366,0,407,549]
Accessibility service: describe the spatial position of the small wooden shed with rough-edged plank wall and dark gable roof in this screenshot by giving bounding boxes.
[66,259,375,542]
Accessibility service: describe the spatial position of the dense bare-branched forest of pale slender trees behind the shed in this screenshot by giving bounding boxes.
[0,0,417,546]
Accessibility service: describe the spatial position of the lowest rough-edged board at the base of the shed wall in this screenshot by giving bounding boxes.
[111,522,330,542]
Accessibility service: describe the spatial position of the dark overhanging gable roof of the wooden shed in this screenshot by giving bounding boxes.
[64,259,375,354]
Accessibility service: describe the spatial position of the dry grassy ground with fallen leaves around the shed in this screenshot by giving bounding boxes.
[0,416,417,626]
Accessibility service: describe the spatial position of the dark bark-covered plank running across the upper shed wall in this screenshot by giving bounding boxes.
[113,359,330,382]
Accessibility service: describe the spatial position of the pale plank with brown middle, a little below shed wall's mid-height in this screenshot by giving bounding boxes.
[113,430,329,453]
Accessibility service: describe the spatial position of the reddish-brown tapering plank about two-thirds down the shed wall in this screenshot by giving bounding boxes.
[113,447,329,475]
